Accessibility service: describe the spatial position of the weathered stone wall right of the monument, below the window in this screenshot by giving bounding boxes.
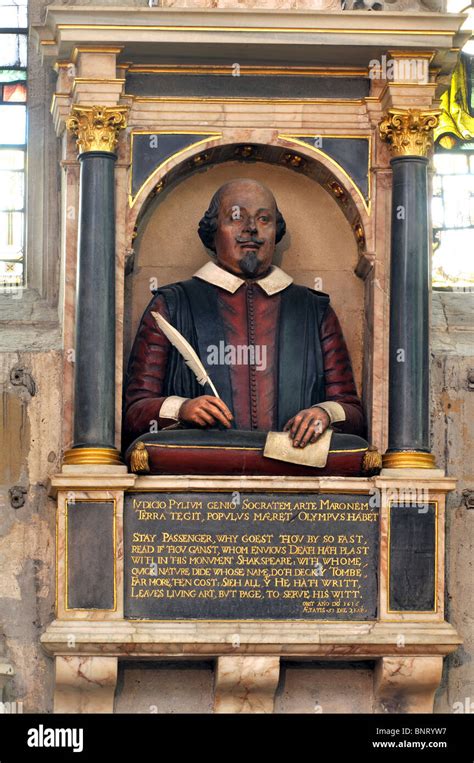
[431,292,474,712]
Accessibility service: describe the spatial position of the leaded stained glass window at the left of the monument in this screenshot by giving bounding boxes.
[0,0,28,288]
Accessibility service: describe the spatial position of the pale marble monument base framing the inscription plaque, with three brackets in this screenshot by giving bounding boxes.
[45,465,462,713]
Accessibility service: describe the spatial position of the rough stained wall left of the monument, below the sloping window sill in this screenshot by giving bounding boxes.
[0,354,61,712]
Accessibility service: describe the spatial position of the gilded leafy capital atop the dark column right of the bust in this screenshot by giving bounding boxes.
[379,109,441,156]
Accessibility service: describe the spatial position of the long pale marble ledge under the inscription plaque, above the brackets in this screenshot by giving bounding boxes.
[41,620,462,660]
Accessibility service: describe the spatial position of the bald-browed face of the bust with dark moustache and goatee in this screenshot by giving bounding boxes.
[214,180,276,278]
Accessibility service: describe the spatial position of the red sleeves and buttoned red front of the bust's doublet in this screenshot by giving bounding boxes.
[124,274,364,443]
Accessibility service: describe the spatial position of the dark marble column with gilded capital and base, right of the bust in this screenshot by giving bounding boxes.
[380,109,439,469]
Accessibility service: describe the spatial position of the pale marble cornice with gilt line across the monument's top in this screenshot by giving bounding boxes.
[33,5,469,75]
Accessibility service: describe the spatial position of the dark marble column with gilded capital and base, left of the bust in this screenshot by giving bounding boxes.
[64,106,127,464]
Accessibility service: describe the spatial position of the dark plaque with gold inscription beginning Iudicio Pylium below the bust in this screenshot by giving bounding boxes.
[124,493,379,620]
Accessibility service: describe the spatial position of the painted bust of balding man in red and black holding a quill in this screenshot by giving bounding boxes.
[124,179,364,448]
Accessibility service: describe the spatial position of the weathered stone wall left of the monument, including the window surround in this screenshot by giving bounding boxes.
[0,0,63,712]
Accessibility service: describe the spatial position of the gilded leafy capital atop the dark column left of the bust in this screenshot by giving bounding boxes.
[66,106,128,154]
